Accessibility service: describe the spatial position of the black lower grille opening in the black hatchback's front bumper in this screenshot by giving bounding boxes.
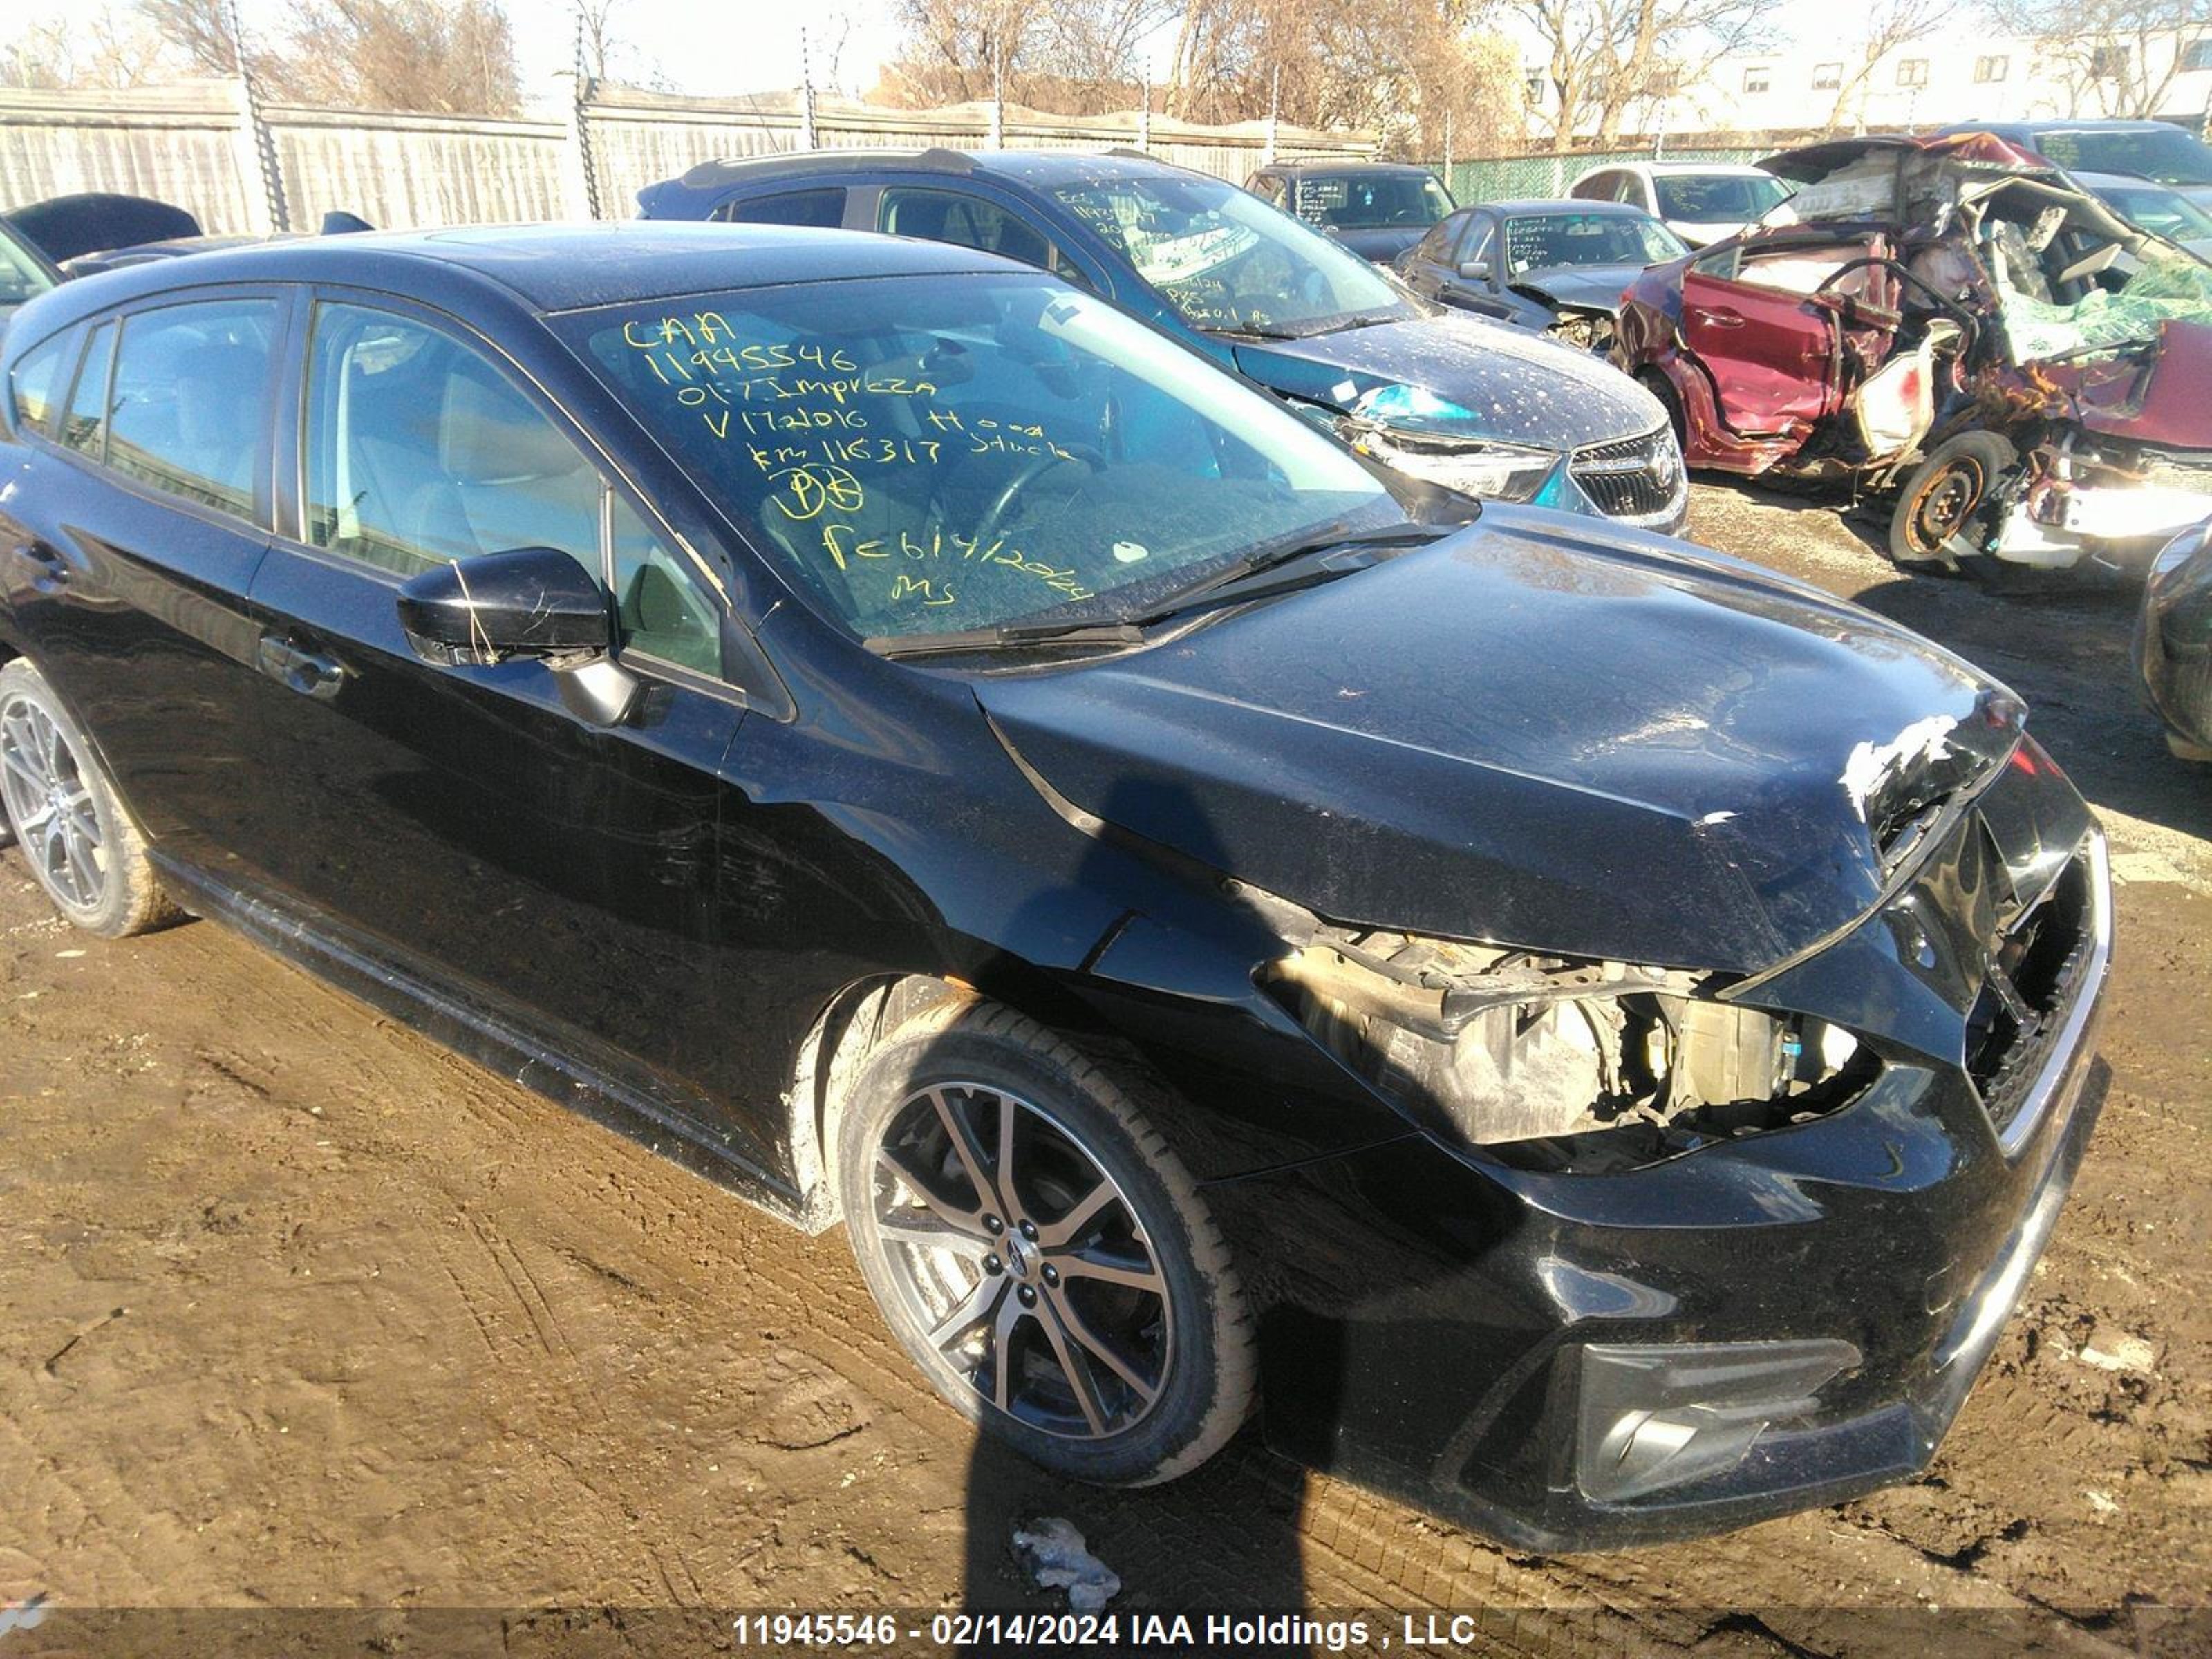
[1967,856,2094,1135]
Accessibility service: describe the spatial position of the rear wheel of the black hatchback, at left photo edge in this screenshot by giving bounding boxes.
[0,657,177,938]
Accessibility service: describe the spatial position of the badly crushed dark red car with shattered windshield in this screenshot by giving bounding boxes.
[1613,133,2212,592]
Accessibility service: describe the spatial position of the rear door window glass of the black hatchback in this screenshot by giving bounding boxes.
[109,299,276,518]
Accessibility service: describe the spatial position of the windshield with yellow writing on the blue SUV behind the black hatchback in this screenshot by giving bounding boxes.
[1053,173,1420,336]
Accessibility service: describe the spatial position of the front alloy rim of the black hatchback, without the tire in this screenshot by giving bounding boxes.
[870,1084,1174,1440]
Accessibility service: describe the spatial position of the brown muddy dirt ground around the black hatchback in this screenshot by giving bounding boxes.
[0,487,2212,1659]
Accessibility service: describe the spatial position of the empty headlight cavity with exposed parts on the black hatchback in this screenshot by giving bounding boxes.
[1263,929,1878,1174]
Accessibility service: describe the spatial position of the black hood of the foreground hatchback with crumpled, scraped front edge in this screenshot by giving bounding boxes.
[975,507,2017,973]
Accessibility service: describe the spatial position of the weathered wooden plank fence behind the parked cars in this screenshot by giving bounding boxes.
[0,82,1374,234]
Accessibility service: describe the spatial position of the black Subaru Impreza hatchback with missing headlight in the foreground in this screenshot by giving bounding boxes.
[0,225,2110,1548]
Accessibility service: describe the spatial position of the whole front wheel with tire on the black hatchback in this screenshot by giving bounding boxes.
[836,1000,1254,1486]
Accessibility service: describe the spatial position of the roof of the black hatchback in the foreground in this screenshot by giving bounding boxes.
[6,219,1029,336]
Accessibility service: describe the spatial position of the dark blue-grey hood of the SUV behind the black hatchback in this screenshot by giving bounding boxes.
[1237,314,1666,449]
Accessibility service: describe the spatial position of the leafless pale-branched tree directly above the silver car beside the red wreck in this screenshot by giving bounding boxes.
[1500,0,1772,148]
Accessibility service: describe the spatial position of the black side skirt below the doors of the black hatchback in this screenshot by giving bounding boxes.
[151,850,821,1232]
